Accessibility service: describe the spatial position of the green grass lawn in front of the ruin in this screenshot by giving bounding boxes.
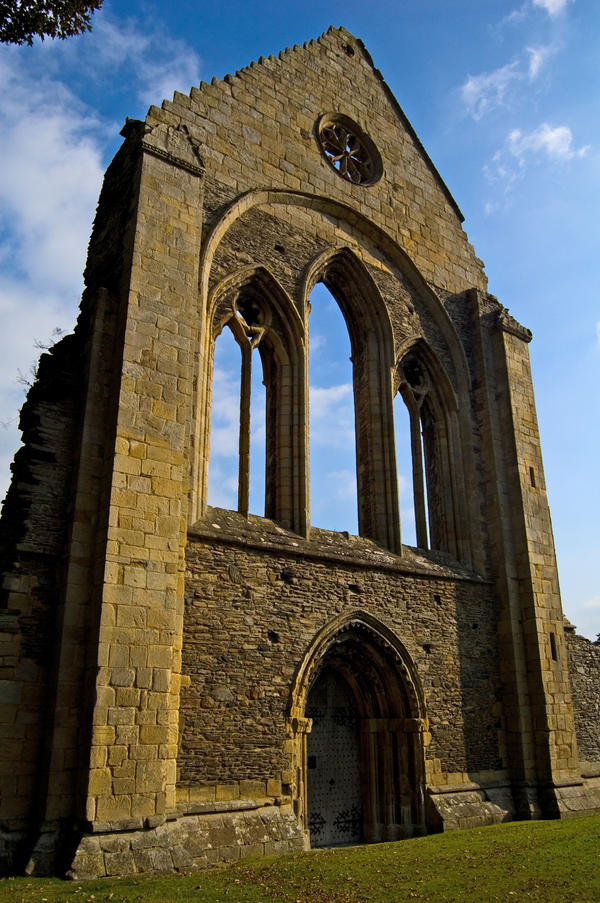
[0,815,600,903]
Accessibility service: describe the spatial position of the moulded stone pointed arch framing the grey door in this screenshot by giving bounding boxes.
[289,610,428,842]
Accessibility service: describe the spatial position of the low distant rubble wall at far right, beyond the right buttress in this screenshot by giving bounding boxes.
[565,629,600,773]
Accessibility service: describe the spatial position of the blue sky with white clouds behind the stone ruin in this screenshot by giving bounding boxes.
[0,0,600,637]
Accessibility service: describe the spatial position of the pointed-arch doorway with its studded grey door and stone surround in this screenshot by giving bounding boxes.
[292,612,427,846]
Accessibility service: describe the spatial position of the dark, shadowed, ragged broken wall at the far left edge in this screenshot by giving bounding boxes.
[0,336,80,856]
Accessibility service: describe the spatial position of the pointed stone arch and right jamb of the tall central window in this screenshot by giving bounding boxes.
[303,248,402,554]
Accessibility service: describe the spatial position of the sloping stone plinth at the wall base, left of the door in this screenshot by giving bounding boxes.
[68,805,307,881]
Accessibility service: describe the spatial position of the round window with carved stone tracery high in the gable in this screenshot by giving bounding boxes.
[317,115,382,185]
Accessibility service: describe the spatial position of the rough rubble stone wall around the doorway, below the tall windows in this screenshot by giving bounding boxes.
[178,509,503,797]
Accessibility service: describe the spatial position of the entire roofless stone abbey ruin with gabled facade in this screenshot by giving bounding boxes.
[0,29,600,878]
